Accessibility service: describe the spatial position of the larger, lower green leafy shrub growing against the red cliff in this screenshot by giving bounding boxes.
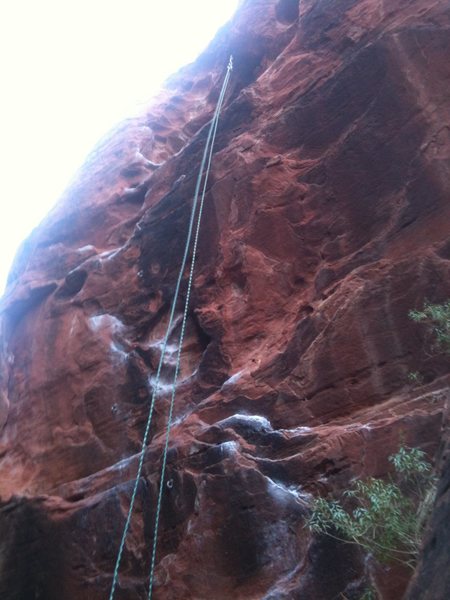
[307,447,436,568]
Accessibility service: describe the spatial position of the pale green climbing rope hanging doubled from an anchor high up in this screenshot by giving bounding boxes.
[109,56,233,600]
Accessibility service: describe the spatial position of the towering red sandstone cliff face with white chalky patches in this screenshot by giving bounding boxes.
[0,0,450,600]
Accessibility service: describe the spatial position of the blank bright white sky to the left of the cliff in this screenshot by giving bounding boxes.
[0,0,238,295]
